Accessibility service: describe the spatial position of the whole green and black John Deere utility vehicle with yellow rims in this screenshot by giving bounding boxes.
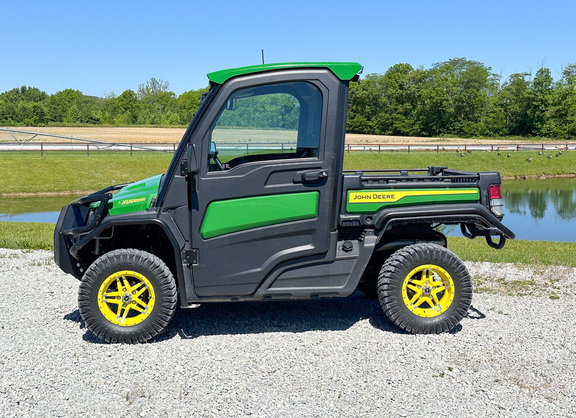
[54,63,514,342]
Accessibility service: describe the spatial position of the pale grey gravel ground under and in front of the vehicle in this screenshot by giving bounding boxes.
[0,249,576,417]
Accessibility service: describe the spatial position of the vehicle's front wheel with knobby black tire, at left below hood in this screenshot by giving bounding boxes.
[78,249,176,343]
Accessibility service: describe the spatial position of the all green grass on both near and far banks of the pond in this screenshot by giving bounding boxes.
[0,151,576,267]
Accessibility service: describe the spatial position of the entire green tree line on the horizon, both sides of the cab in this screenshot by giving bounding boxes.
[0,58,576,139]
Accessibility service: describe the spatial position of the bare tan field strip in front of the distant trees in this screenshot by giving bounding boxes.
[0,127,568,145]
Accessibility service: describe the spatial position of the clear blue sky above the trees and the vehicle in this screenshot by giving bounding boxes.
[0,0,576,97]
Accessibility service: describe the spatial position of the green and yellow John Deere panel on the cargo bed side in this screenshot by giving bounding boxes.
[346,188,480,213]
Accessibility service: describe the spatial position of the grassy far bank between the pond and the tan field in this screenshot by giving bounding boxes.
[0,151,576,194]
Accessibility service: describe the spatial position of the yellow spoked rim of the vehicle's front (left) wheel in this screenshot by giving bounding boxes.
[98,270,155,327]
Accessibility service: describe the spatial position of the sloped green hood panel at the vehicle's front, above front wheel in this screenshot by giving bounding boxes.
[95,174,162,215]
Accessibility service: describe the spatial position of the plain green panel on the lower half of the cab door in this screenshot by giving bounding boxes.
[200,192,319,239]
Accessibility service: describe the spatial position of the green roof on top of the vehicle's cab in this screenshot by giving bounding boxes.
[208,62,362,84]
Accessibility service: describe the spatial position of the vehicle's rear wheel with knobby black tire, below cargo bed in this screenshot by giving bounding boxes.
[378,243,472,334]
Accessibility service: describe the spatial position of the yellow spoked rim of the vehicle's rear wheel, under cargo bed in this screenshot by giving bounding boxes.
[402,264,454,318]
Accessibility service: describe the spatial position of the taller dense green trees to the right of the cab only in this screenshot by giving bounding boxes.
[347,58,576,139]
